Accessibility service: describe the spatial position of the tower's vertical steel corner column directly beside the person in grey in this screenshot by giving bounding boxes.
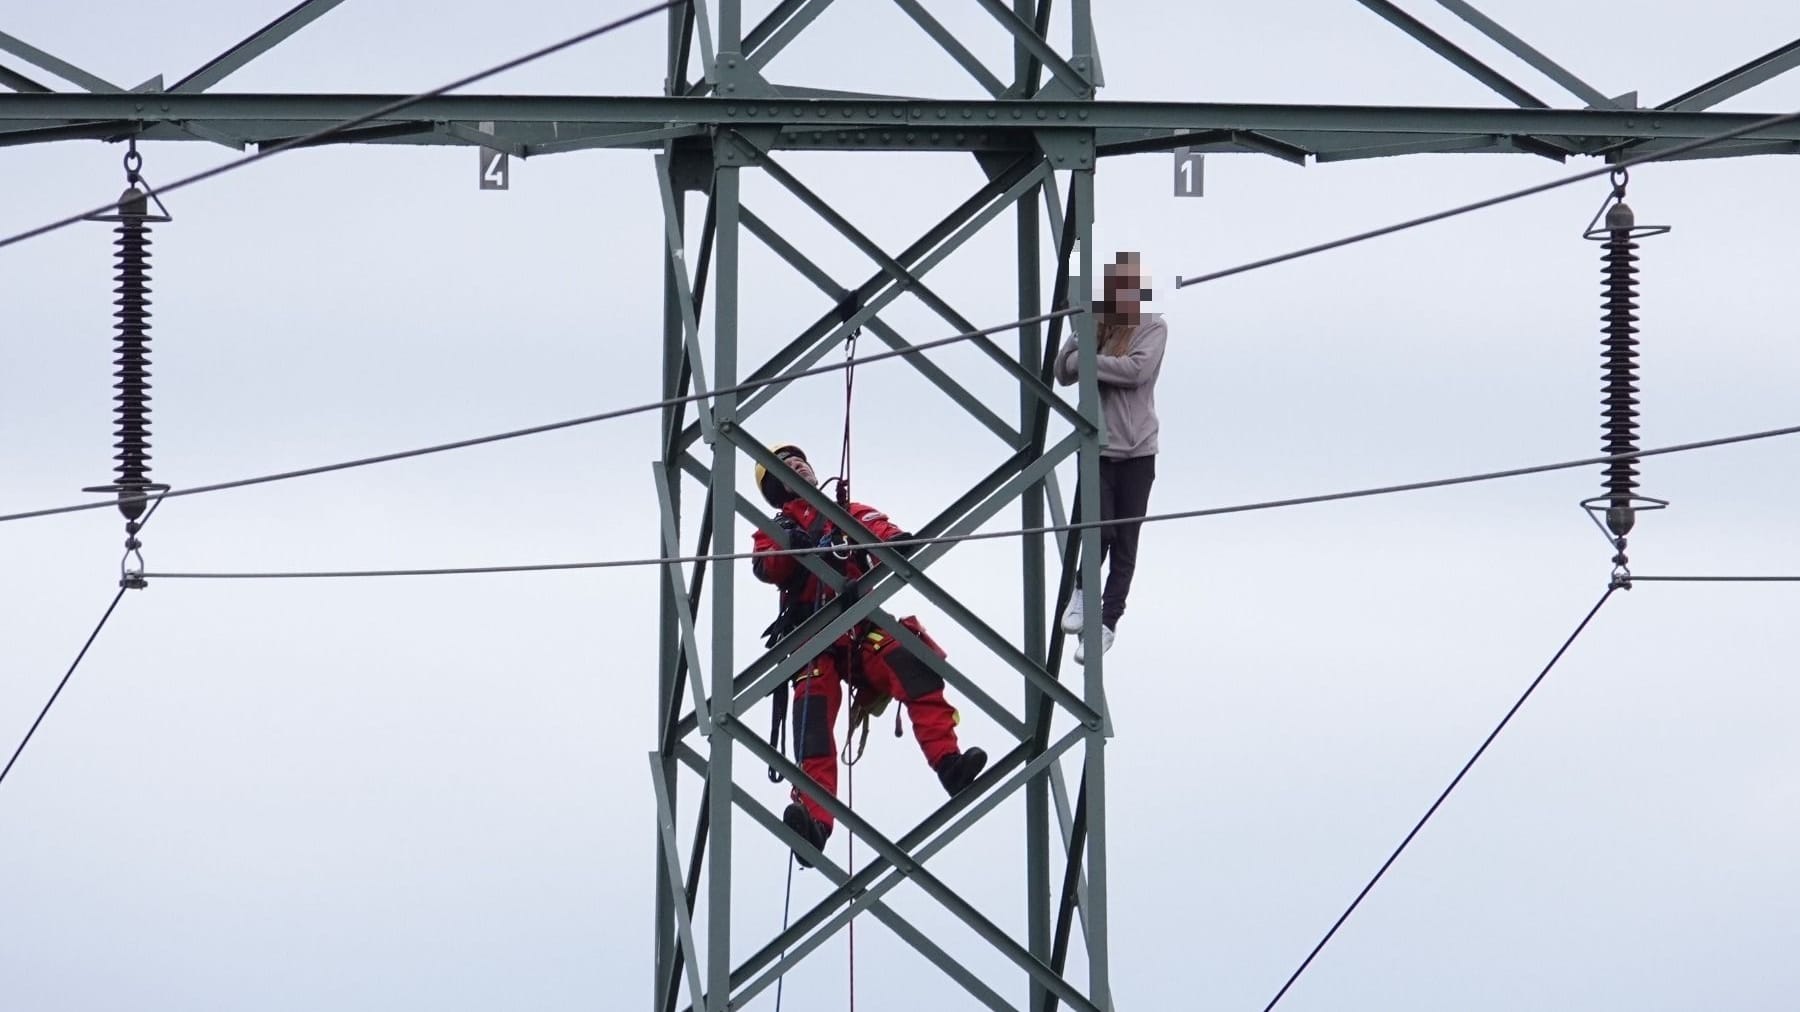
[1069,161,1111,1008]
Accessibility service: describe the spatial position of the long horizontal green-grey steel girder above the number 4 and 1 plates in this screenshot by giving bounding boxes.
[0,94,1800,157]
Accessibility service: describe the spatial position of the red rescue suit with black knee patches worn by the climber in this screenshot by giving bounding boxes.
[751,497,958,827]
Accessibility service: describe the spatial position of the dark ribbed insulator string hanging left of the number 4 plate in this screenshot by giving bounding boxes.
[83,139,171,591]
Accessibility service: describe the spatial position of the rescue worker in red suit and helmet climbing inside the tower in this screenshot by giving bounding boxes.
[751,445,988,866]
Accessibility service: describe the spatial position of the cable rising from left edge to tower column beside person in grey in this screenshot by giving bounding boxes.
[0,308,1087,524]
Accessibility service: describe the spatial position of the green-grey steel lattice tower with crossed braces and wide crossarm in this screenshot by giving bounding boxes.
[0,0,1800,1012]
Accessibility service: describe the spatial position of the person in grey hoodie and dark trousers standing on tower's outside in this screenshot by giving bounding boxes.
[1057,252,1168,664]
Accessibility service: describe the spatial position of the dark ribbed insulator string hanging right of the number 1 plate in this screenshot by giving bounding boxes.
[1582,169,1669,589]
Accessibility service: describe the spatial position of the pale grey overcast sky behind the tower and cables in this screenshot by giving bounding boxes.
[0,0,1800,1012]
